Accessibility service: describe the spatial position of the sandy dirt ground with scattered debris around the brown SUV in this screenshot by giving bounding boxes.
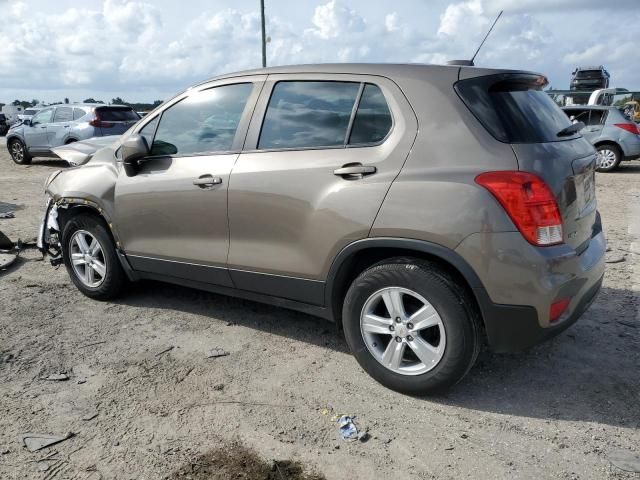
[0,142,640,480]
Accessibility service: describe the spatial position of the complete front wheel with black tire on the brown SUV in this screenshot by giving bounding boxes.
[62,214,127,300]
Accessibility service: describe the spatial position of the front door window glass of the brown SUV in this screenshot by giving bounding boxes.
[151,83,253,155]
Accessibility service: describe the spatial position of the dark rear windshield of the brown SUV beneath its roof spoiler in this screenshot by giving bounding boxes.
[455,74,578,143]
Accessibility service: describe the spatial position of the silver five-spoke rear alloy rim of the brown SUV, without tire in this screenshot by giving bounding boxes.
[360,287,446,375]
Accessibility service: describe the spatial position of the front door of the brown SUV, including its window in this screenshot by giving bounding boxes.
[115,82,261,286]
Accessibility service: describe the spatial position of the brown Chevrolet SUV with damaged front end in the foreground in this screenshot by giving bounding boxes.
[38,64,606,394]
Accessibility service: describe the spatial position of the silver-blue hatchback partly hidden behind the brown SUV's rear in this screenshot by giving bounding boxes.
[563,105,640,172]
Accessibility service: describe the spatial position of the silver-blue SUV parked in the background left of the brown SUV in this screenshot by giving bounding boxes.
[7,104,140,165]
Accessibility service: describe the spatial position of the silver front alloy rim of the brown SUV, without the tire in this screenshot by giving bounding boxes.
[69,230,107,288]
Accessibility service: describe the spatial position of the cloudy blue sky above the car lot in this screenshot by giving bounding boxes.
[0,0,640,102]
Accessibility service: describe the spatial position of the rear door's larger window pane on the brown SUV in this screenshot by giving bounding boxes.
[258,81,360,149]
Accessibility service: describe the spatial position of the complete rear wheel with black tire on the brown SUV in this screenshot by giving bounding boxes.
[342,257,481,395]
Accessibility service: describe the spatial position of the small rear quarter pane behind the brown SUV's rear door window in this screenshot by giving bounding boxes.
[349,84,393,145]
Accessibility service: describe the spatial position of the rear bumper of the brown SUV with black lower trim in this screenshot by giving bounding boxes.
[456,226,606,352]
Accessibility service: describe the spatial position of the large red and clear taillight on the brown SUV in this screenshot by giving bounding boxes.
[476,171,562,247]
